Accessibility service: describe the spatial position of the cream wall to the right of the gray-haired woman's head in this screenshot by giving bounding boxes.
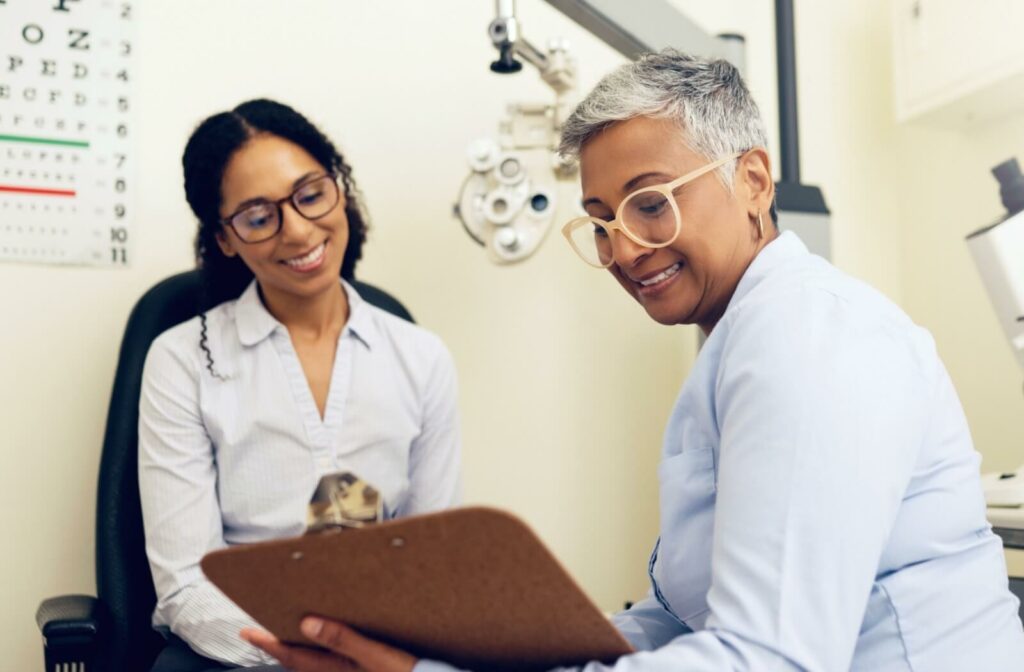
[674,0,1024,576]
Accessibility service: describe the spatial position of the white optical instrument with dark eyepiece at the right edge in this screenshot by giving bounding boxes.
[967,159,1024,507]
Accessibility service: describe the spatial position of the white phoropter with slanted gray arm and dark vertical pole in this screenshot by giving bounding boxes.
[455,0,831,263]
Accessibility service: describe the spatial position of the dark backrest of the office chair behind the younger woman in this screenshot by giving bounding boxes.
[96,270,413,670]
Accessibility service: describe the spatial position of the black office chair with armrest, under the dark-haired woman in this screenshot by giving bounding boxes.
[36,270,413,672]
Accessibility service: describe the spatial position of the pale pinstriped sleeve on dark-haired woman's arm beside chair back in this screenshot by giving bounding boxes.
[138,339,274,666]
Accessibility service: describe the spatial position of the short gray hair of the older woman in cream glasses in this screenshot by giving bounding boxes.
[558,49,768,188]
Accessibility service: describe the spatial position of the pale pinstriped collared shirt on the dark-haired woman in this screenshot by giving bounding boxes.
[139,282,460,665]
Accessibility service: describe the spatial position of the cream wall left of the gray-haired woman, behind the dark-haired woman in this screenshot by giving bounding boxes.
[0,0,695,670]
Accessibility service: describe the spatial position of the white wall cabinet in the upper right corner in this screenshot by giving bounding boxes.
[893,0,1024,128]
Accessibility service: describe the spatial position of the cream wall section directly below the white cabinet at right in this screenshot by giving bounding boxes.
[893,114,1024,576]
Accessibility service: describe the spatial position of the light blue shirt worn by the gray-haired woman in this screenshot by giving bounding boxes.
[417,234,1024,672]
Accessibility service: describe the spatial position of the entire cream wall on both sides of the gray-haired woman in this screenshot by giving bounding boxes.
[6,0,1024,670]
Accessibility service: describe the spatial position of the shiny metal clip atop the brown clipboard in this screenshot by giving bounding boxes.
[305,471,384,535]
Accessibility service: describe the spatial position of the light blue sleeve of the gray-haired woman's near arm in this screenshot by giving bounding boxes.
[417,289,937,672]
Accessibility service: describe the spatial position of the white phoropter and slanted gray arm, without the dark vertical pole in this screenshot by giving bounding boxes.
[454,0,743,263]
